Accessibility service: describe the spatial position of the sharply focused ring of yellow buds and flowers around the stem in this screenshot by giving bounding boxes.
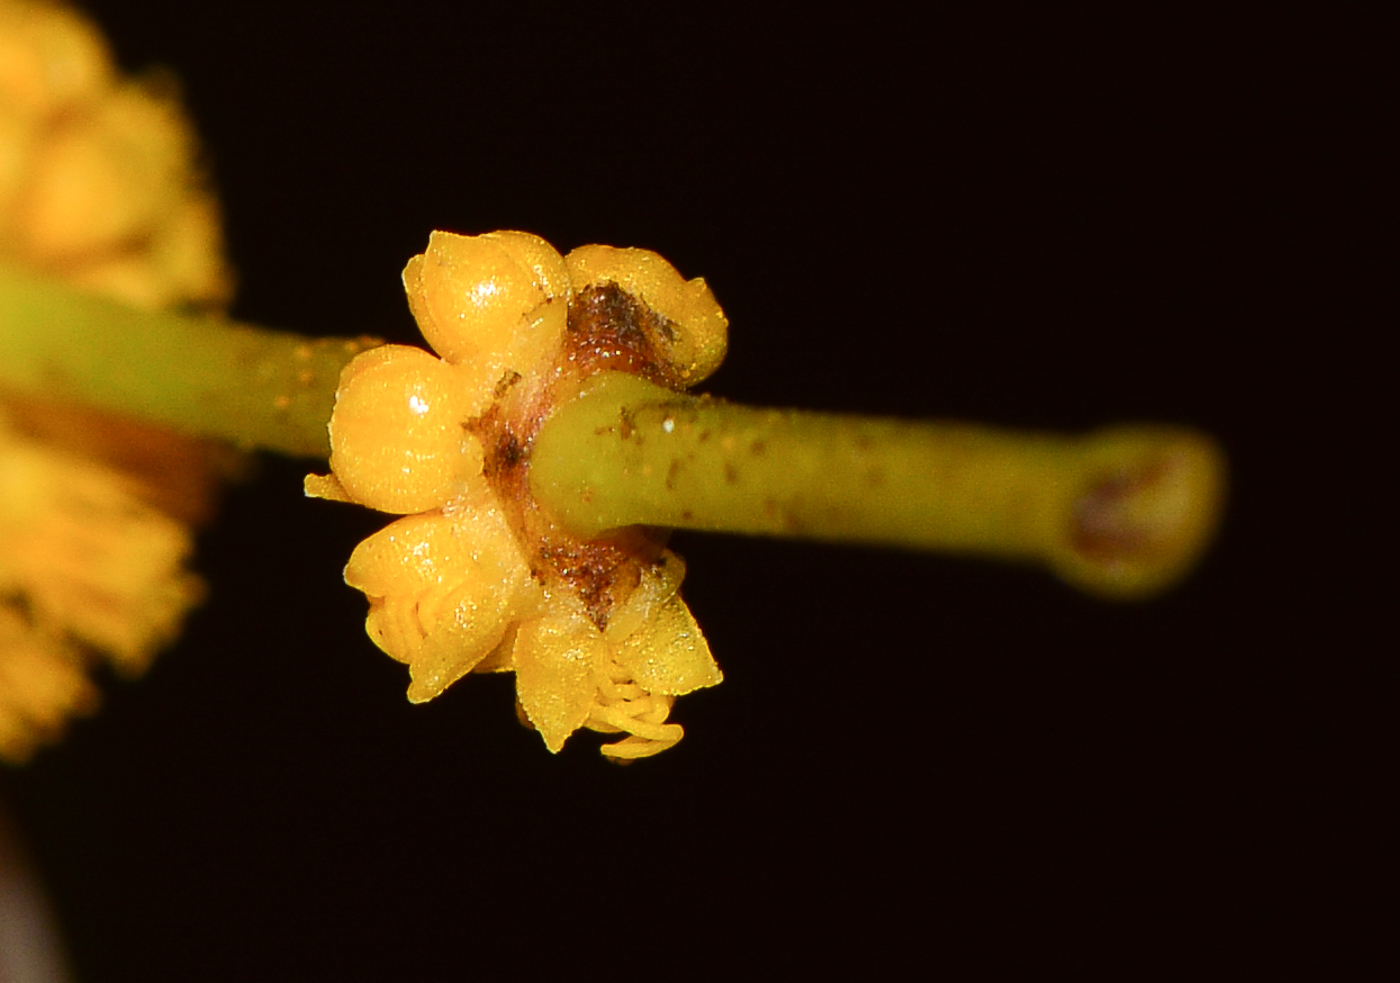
[307,232,727,759]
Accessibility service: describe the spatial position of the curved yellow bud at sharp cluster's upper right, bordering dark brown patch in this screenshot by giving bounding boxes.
[564,245,729,388]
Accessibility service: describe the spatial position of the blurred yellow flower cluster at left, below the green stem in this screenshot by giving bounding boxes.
[0,412,203,762]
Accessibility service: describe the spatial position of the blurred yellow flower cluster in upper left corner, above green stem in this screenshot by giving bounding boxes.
[0,0,232,309]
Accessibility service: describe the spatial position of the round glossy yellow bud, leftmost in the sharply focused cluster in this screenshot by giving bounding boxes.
[330,344,482,514]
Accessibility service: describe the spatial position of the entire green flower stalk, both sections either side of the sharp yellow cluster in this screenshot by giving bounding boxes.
[0,265,1225,598]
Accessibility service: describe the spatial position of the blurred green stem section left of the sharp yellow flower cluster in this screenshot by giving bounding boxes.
[0,265,374,458]
